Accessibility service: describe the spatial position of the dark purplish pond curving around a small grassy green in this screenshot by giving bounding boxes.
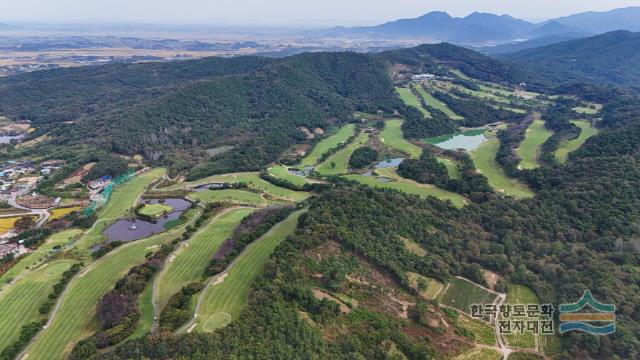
[103,198,191,243]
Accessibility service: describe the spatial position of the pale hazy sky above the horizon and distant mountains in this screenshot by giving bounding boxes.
[0,0,640,26]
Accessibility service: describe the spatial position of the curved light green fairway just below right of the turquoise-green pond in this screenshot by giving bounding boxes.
[471,138,534,199]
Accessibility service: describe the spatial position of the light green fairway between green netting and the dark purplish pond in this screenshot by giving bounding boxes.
[98,168,166,219]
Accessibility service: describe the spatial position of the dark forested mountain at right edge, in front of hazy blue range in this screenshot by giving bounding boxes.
[499,30,640,88]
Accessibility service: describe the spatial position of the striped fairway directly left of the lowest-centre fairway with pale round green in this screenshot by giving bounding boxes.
[155,209,253,309]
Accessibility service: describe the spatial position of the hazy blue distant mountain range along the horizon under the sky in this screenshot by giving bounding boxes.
[327,7,640,45]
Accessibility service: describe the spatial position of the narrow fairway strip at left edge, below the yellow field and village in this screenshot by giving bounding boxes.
[0,229,82,286]
